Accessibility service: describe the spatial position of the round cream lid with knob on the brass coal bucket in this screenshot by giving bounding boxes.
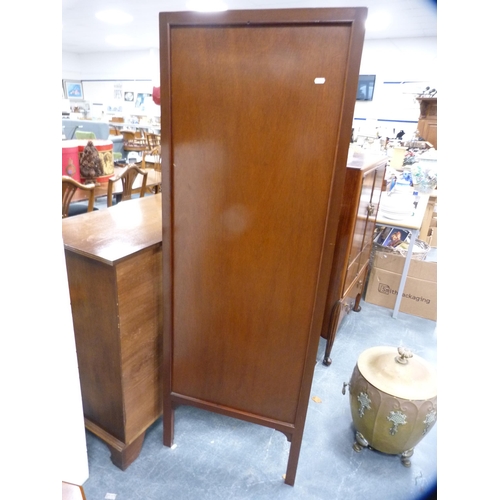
[358,346,437,401]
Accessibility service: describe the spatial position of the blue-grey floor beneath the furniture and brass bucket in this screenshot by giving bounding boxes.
[83,302,437,500]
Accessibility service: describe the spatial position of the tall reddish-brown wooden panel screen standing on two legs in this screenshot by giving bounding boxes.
[160,8,367,485]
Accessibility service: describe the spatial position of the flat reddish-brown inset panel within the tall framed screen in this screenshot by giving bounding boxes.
[172,22,350,422]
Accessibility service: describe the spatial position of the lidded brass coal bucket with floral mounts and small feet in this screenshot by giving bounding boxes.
[342,346,437,467]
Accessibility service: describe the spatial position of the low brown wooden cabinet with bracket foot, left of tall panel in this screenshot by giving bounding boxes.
[62,194,163,470]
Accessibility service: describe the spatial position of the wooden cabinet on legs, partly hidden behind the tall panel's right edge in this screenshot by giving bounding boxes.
[321,155,387,365]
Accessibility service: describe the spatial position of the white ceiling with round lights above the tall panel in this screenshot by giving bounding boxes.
[62,0,437,54]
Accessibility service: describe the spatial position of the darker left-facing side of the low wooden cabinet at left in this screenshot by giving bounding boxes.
[65,250,125,441]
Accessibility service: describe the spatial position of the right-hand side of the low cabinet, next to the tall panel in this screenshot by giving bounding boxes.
[116,245,163,442]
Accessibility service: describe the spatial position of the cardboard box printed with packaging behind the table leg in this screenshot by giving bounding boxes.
[365,252,437,321]
